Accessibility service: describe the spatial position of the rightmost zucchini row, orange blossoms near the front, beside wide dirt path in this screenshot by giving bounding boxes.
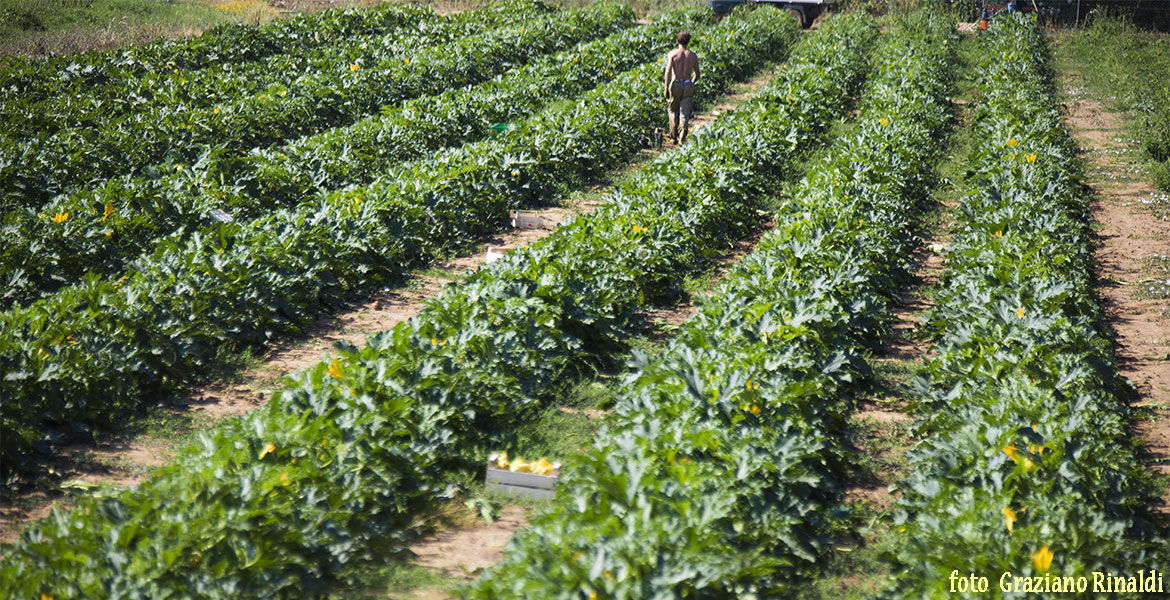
[886,16,1164,599]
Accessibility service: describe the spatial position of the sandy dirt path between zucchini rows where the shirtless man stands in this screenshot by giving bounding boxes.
[0,40,795,542]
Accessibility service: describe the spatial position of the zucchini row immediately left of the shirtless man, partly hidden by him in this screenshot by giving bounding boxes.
[0,4,798,469]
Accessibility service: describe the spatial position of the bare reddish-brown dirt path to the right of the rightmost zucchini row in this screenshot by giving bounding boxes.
[1060,47,1170,515]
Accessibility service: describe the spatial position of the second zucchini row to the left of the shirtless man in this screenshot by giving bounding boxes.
[0,7,709,308]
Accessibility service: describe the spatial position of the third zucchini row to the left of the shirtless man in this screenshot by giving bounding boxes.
[0,0,613,207]
